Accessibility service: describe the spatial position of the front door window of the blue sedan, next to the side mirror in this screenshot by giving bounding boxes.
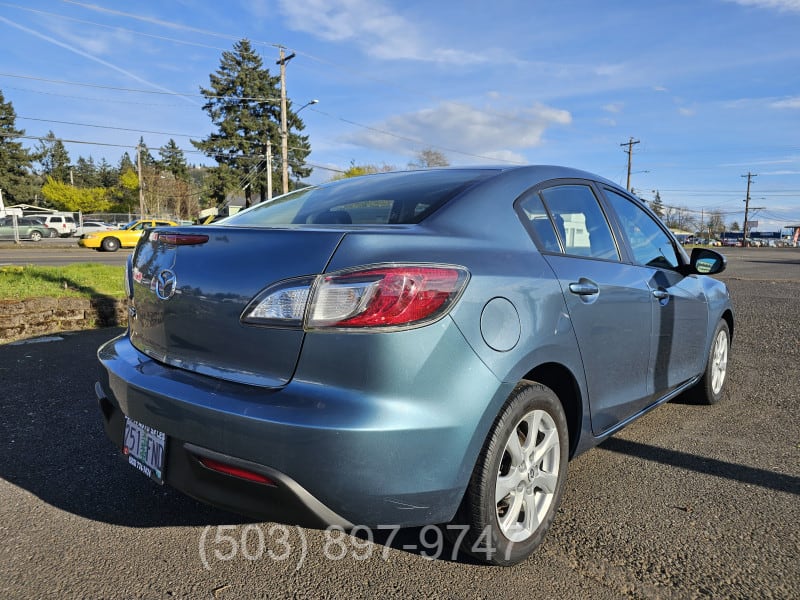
[603,189,680,269]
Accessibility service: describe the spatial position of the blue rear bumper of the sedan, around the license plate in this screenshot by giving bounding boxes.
[97,328,510,526]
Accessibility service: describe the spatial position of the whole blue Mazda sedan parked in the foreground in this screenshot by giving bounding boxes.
[95,166,734,565]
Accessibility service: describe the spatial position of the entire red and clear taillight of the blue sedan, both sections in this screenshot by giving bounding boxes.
[242,265,469,331]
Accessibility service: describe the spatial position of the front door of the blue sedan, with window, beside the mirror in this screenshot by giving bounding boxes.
[602,187,708,400]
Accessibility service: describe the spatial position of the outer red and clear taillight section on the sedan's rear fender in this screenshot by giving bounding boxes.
[306,265,467,329]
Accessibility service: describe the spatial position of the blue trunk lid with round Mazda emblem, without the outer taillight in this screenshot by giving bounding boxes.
[130,226,344,387]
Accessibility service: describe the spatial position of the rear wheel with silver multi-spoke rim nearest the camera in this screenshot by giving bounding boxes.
[454,381,569,566]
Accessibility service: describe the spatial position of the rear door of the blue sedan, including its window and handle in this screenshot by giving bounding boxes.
[517,181,653,434]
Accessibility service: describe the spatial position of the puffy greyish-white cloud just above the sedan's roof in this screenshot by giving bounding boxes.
[346,102,572,163]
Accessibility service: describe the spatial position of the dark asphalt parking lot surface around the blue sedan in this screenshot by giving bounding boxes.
[0,248,800,598]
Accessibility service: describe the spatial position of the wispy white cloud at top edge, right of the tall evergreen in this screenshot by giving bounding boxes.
[279,0,488,64]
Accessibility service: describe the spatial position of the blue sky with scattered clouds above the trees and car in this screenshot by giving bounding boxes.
[0,0,800,231]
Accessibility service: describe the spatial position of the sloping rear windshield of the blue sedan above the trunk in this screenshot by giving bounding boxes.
[220,169,495,226]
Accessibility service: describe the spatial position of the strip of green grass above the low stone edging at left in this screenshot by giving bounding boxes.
[0,263,125,300]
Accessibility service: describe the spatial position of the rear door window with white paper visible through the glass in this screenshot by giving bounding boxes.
[541,184,619,260]
